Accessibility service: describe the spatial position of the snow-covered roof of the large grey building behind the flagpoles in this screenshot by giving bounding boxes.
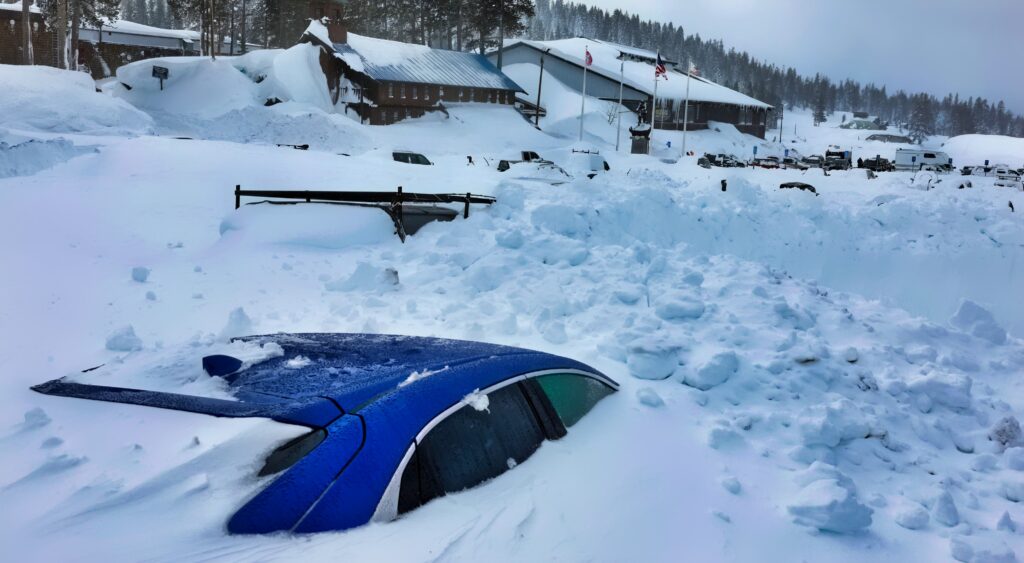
[505,38,771,109]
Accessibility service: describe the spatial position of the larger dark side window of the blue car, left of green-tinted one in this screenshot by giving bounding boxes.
[398,384,545,514]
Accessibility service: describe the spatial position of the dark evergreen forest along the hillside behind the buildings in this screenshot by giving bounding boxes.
[73,0,1024,138]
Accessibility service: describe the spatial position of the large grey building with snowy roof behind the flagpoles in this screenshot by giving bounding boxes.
[488,38,772,138]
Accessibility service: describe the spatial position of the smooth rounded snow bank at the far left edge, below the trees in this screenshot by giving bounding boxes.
[0,64,152,134]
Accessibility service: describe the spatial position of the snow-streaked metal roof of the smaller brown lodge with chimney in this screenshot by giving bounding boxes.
[334,33,523,92]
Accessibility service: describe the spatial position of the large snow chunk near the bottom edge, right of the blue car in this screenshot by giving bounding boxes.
[786,479,874,533]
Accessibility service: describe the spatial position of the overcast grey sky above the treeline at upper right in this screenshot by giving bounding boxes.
[577,0,1024,114]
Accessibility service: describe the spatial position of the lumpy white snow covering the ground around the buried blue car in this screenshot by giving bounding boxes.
[0,59,1024,561]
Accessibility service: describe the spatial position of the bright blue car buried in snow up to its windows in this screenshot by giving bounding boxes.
[33,334,618,533]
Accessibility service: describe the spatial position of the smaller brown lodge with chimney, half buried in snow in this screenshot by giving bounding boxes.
[301,7,524,125]
